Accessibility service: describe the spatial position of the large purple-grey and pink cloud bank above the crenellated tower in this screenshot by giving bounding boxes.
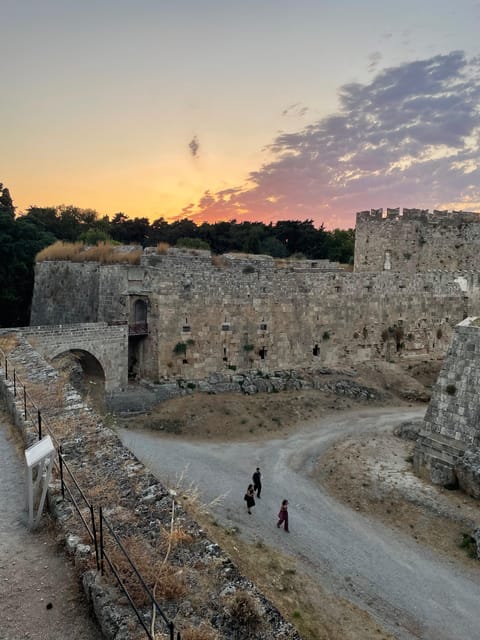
[184,51,480,227]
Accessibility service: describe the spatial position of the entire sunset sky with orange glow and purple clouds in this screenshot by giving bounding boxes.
[0,0,480,229]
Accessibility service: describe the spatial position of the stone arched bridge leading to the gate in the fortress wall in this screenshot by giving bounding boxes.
[22,322,128,393]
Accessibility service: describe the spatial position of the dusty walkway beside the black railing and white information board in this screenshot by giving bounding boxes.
[0,405,102,640]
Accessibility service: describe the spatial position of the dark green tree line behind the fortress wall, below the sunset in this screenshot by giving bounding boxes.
[0,183,354,327]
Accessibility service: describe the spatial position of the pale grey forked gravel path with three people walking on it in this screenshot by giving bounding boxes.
[119,408,480,640]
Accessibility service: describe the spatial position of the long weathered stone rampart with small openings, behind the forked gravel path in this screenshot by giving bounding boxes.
[31,250,480,381]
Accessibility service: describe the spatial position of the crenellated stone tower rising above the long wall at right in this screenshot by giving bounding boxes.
[355,209,480,273]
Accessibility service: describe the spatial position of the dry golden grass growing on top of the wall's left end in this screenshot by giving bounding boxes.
[36,241,142,264]
